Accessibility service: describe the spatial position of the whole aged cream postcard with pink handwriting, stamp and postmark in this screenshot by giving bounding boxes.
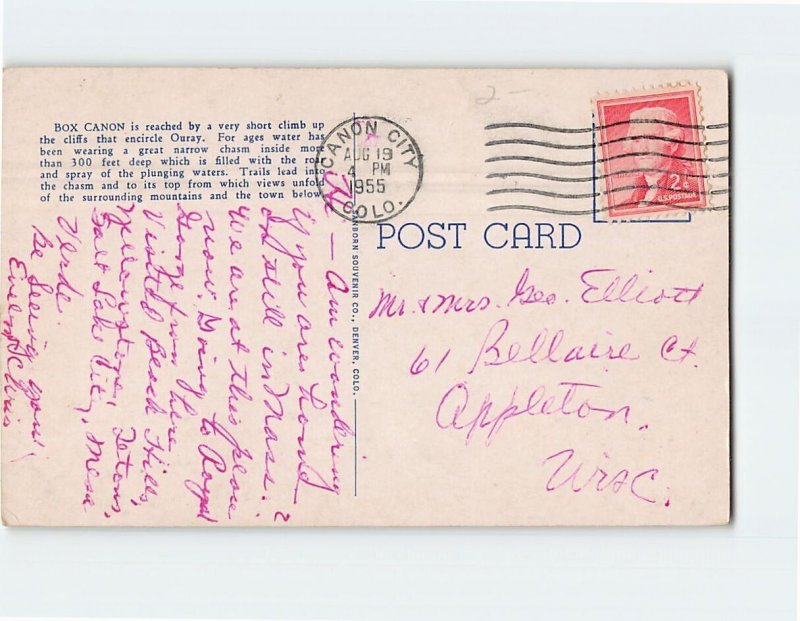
[2,68,729,526]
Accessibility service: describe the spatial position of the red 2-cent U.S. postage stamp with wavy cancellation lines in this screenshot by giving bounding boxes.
[596,87,707,218]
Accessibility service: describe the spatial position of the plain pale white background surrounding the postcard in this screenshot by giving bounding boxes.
[0,0,800,621]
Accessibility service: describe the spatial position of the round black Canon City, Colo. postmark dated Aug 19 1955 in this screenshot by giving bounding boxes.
[315,116,422,223]
